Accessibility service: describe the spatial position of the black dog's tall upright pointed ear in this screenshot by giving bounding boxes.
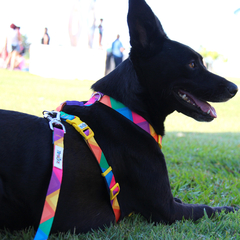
[127,0,167,53]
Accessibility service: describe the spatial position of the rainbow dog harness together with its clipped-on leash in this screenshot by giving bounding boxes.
[34,92,162,240]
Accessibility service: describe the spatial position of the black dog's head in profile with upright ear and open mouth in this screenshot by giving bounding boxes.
[128,0,238,121]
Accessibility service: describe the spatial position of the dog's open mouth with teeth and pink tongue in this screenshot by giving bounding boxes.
[177,90,217,120]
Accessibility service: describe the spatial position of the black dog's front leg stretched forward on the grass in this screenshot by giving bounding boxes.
[135,151,234,223]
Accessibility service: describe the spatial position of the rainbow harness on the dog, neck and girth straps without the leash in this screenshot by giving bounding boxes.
[57,92,162,219]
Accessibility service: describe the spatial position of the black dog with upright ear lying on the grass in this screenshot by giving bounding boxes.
[0,0,238,233]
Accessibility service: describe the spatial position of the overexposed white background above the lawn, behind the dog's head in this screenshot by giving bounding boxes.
[0,0,240,80]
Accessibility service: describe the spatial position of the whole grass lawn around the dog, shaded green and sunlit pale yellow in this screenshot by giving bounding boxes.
[0,70,240,240]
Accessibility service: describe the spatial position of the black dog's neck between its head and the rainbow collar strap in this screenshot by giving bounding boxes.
[92,59,170,136]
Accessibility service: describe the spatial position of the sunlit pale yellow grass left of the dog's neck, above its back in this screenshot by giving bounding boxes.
[0,70,94,116]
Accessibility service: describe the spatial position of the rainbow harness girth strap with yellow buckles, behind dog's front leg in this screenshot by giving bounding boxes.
[60,112,121,222]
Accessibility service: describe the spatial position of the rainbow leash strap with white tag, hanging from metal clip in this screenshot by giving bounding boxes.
[34,127,64,240]
